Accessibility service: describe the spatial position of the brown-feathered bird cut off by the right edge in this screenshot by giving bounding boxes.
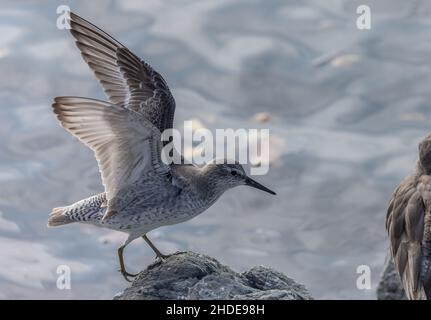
[386,135,431,300]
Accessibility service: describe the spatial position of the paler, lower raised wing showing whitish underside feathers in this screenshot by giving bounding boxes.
[53,97,170,219]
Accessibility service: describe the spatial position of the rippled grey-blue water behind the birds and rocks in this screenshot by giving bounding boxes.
[0,0,431,299]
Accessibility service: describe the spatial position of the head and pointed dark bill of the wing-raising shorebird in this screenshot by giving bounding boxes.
[204,160,276,195]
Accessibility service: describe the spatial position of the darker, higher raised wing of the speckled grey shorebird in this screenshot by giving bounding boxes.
[70,12,175,132]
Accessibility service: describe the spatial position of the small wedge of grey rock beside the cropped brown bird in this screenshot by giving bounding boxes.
[377,253,407,300]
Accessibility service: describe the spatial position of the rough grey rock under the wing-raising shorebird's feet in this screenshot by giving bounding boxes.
[114,252,312,300]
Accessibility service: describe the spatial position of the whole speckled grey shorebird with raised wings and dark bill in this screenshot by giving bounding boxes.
[48,12,275,281]
